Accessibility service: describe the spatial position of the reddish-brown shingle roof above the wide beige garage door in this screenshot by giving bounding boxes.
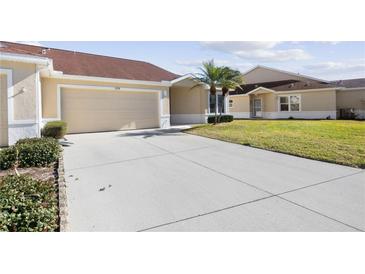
[0,41,180,82]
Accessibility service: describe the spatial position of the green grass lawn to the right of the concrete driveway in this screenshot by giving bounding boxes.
[186,120,365,168]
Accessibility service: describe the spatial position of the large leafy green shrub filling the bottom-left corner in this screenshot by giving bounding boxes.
[0,175,58,232]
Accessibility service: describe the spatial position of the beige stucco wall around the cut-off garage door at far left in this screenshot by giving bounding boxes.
[0,61,36,121]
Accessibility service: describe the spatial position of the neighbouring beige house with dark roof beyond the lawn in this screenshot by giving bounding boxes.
[229,66,365,119]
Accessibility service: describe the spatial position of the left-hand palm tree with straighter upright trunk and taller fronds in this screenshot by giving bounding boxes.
[193,60,223,124]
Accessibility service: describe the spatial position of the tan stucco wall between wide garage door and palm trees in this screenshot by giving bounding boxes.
[170,86,208,114]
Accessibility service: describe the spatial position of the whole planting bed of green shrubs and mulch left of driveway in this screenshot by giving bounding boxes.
[0,138,64,232]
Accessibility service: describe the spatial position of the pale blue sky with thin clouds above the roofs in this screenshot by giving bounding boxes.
[21,41,365,80]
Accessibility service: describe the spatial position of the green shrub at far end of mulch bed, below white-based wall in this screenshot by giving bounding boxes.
[16,138,61,167]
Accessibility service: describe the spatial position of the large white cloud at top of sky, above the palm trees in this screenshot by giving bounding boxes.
[201,41,311,62]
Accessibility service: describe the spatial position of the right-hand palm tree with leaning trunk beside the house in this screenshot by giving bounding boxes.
[218,67,244,122]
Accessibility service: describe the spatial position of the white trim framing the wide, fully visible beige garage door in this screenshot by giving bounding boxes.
[51,84,170,128]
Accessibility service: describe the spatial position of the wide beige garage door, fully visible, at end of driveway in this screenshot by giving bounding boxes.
[61,88,159,133]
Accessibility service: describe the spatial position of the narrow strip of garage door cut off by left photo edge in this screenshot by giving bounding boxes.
[0,74,8,146]
